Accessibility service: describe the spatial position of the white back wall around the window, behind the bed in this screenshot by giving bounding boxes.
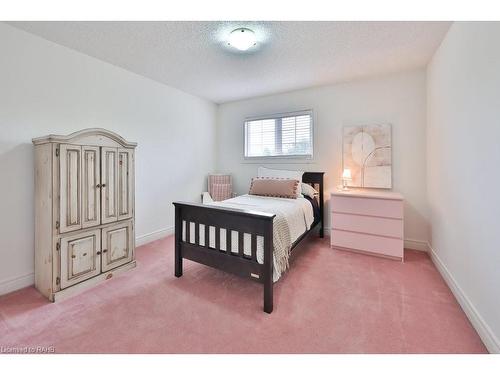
[217,70,428,247]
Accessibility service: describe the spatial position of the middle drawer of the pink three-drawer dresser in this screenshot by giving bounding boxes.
[332,212,403,239]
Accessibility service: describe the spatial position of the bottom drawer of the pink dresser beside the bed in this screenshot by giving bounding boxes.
[331,229,403,258]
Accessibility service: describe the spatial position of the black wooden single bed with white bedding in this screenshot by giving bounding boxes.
[173,172,324,314]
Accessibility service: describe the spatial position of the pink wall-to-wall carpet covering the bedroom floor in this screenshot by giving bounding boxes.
[0,237,486,353]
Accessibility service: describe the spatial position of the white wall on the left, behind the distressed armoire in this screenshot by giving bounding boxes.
[0,23,217,294]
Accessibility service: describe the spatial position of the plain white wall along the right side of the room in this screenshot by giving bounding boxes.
[427,22,500,352]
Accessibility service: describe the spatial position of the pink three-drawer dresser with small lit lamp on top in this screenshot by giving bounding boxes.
[330,190,404,261]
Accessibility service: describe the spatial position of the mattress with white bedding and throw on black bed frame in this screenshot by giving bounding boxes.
[182,194,314,281]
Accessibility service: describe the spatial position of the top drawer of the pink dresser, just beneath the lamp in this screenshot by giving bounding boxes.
[330,195,403,219]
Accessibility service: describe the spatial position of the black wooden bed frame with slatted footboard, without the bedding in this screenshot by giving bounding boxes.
[173,172,324,314]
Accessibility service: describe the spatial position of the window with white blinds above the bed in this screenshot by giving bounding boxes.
[245,111,313,158]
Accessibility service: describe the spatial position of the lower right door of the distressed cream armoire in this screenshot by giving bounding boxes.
[102,221,134,272]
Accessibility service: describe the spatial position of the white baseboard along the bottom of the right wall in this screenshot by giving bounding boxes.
[427,244,500,353]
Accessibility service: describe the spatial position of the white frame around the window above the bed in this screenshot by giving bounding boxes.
[243,109,314,161]
